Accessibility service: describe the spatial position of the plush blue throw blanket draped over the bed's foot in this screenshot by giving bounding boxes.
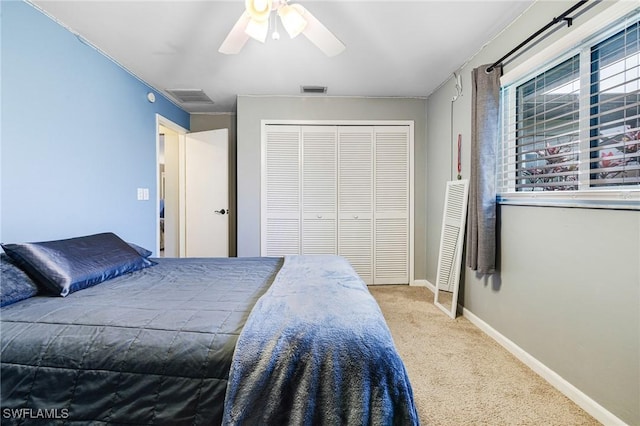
[223,256,419,425]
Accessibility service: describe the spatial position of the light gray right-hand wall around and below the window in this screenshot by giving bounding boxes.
[427,1,640,425]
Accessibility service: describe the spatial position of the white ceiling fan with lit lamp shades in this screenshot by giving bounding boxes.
[218,0,345,56]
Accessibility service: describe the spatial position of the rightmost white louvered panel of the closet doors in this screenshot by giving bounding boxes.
[373,126,410,284]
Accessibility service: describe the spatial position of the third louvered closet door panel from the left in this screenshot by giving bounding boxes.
[338,126,373,284]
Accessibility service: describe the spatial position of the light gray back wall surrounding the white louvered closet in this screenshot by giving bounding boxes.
[237,96,426,279]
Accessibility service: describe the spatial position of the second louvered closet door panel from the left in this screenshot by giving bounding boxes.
[302,126,338,254]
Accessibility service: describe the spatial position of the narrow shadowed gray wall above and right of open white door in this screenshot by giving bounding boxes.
[190,114,238,257]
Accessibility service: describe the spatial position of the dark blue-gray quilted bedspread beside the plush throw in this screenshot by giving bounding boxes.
[0,258,282,426]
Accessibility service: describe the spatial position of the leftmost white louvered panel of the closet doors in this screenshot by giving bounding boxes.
[262,125,301,256]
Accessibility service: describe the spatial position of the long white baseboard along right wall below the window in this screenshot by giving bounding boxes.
[462,308,626,426]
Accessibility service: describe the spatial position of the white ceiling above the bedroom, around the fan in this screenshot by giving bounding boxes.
[32,0,534,112]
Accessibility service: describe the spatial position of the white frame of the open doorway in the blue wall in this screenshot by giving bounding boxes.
[155,114,189,257]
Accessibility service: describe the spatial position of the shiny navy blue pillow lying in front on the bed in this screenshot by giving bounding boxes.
[1,232,155,297]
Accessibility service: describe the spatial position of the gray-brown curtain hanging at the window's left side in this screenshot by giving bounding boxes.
[466,65,502,274]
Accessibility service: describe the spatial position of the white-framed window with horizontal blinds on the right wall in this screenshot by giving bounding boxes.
[498,12,640,209]
